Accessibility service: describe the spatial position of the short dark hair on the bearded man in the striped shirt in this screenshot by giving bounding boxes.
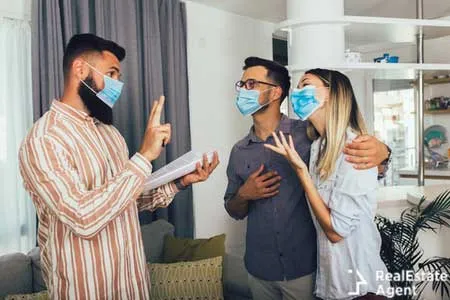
[63,33,125,79]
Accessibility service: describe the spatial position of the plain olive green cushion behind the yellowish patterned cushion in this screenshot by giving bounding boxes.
[163,234,225,263]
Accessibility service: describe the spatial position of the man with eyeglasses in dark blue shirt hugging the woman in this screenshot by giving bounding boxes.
[224,57,389,300]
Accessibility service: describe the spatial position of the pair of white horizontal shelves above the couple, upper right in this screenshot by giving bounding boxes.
[275,16,450,76]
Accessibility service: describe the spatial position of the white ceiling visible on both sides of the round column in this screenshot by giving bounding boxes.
[188,0,450,23]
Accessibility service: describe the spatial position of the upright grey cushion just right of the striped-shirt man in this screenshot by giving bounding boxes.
[141,220,175,263]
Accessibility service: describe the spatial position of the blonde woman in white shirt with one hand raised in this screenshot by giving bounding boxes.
[265,69,389,299]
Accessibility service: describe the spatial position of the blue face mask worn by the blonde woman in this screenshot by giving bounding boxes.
[290,85,320,121]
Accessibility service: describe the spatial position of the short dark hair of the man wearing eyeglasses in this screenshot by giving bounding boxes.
[242,56,291,103]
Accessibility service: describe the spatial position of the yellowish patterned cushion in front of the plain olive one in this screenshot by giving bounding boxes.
[148,256,223,300]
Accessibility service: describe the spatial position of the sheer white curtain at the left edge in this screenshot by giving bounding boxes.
[0,18,36,255]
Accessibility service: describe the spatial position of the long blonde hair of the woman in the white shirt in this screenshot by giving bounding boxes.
[305,69,367,180]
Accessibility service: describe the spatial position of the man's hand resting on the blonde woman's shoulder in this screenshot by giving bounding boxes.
[344,135,389,170]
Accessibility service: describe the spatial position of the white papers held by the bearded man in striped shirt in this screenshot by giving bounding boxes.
[144,151,214,191]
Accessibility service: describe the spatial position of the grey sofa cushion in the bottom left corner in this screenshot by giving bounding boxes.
[0,253,33,299]
